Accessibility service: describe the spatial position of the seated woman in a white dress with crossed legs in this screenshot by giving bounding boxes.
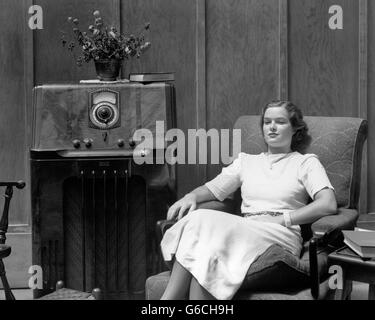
[161,101,337,299]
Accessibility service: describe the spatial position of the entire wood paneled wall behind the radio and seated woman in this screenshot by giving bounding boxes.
[0,0,375,231]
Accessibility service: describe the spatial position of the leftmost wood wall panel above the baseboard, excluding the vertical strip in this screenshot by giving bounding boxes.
[0,0,30,226]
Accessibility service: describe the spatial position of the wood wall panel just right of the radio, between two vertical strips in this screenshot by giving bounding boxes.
[206,0,280,180]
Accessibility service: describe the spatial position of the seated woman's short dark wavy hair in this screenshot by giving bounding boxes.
[260,100,311,153]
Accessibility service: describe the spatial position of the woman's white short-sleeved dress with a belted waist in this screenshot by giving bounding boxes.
[161,152,333,300]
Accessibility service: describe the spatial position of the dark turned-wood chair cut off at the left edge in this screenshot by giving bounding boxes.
[0,181,26,300]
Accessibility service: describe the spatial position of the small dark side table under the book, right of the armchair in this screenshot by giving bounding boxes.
[328,214,375,300]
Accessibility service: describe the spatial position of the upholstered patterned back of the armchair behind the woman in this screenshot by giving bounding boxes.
[234,116,368,209]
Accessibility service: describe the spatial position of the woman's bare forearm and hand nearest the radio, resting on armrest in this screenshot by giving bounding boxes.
[167,185,217,220]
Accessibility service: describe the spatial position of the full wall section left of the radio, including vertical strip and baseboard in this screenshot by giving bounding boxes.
[0,0,31,288]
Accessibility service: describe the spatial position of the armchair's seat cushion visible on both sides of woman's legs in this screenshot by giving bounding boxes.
[146,244,328,300]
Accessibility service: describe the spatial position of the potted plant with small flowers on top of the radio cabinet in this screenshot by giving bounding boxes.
[61,10,151,81]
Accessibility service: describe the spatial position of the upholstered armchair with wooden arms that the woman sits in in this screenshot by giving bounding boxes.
[146,116,367,300]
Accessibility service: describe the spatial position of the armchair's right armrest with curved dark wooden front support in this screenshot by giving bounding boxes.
[309,208,358,299]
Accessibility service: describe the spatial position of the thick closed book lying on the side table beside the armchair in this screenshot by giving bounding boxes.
[343,229,375,259]
